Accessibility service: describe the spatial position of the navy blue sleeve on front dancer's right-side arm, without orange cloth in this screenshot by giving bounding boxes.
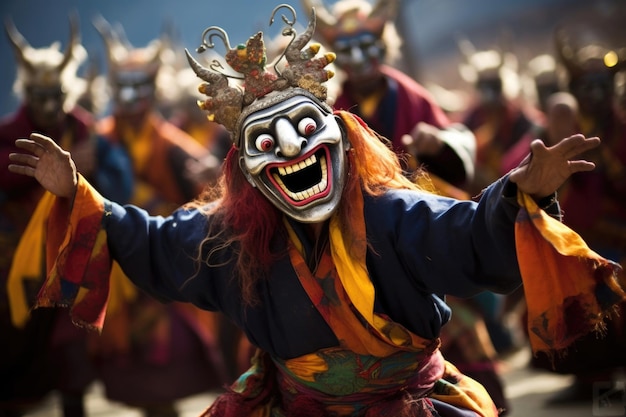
[366,178,521,297]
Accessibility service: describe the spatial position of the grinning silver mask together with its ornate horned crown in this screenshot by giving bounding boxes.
[186,4,348,223]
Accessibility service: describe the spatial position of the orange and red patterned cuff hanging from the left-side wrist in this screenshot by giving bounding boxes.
[35,175,112,331]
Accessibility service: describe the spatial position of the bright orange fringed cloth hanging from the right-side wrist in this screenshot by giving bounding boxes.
[515,192,626,357]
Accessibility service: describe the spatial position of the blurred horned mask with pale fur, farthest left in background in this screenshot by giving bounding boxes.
[5,16,87,130]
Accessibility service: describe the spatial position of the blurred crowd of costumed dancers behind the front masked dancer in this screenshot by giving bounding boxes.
[0,0,626,417]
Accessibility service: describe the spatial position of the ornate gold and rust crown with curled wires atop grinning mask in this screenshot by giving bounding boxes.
[185,4,335,144]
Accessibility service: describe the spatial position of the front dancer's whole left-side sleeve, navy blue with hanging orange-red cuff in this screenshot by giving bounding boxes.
[36,175,232,330]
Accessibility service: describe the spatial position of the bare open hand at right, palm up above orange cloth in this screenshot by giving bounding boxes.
[509,134,600,199]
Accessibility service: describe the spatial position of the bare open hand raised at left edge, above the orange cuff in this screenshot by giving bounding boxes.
[9,133,78,199]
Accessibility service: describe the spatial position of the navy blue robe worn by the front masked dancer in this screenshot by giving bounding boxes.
[103,179,524,359]
